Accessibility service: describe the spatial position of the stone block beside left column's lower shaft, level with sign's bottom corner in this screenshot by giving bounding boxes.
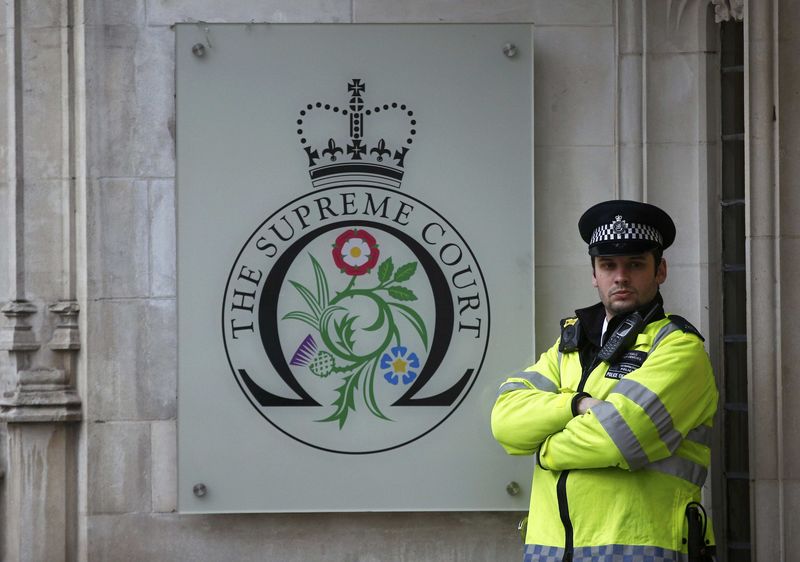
[86,422,152,512]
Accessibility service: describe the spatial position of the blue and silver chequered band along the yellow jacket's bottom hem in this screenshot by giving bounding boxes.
[523,544,687,562]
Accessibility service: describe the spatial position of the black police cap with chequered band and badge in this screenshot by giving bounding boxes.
[578,199,675,256]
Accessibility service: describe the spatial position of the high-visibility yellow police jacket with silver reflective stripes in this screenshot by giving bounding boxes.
[492,297,717,562]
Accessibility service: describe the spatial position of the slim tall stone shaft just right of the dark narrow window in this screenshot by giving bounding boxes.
[744,0,780,560]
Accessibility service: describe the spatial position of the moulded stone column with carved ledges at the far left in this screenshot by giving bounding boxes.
[0,0,81,562]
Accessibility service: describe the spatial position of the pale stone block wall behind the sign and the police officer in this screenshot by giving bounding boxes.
[0,0,736,562]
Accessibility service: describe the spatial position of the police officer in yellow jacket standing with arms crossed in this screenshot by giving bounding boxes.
[492,200,717,562]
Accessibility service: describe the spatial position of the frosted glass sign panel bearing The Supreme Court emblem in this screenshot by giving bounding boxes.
[177,24,533,512]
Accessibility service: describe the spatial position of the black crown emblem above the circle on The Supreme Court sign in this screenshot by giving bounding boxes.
[297,79,417,188]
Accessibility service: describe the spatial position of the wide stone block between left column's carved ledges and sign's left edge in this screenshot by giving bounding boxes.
[86,299,177,421]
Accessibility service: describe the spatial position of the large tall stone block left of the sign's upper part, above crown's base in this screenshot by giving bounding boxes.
[86,25,175,178]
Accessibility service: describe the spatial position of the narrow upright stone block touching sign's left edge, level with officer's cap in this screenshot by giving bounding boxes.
[149,180,176,297]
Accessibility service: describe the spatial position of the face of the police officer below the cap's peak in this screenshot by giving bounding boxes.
[592,252,667,318]
